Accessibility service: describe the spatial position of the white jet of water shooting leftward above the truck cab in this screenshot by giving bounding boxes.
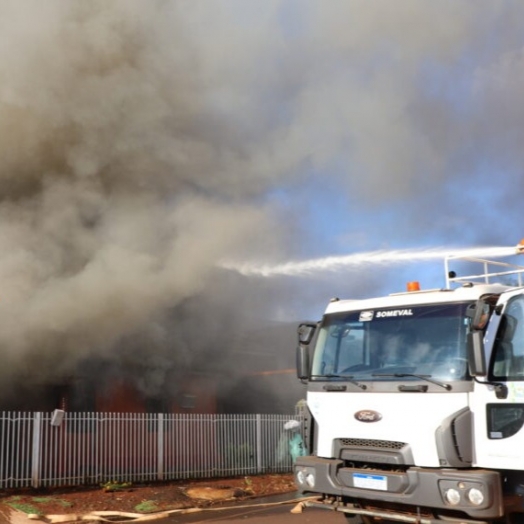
[222,247,517,277]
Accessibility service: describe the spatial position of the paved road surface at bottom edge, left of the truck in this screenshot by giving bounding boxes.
[165,499,346,524]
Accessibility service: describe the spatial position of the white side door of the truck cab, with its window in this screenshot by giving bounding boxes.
[471,290,524,470]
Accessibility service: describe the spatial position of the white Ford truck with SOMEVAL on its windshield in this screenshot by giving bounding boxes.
[294,241,524,524]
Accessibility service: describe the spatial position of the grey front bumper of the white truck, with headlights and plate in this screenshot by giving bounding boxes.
[295,456,504,522]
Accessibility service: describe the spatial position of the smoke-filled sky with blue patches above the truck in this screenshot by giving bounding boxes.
[0,0,524,400]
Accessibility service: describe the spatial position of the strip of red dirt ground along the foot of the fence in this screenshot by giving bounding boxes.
[0,474,296,515]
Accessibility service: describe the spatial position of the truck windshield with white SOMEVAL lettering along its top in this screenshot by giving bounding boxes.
[312,303,469,381]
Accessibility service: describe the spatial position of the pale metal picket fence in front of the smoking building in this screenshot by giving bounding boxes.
[0,412,297,488]
